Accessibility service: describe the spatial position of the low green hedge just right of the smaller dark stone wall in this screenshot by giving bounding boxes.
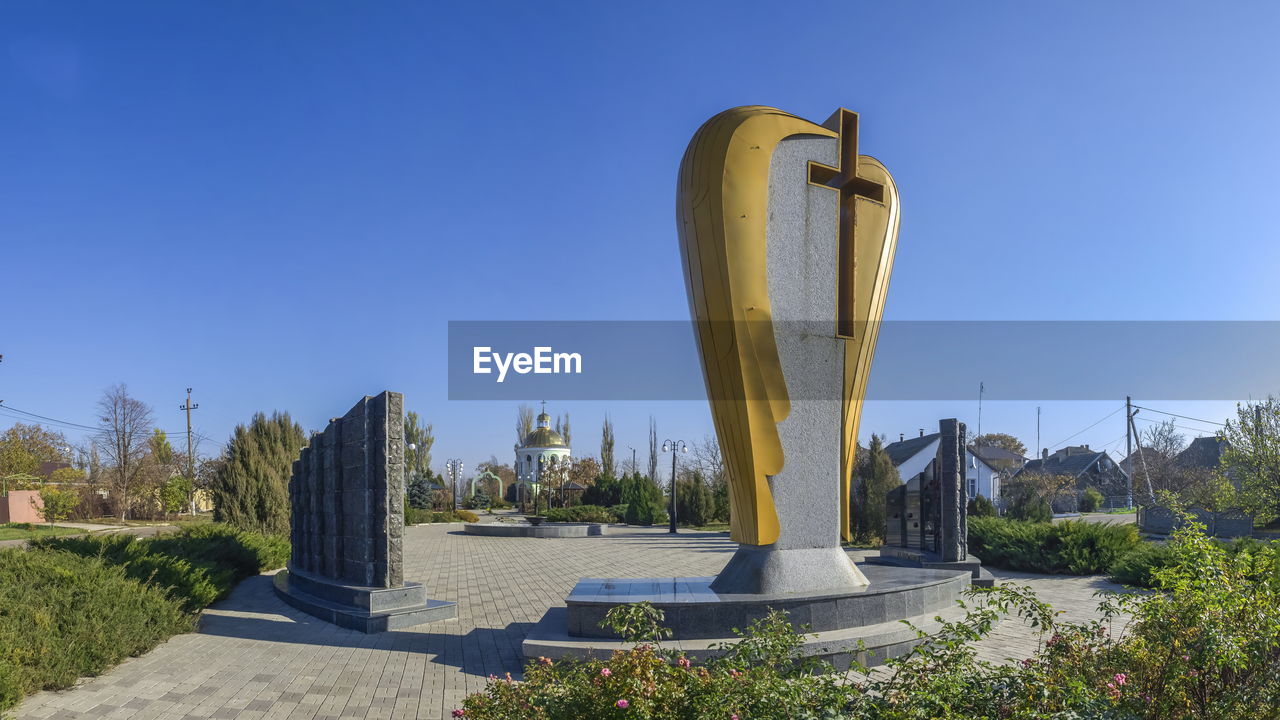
[969,518,1139,575]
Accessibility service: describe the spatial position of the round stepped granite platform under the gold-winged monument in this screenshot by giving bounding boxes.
[524,565,972,669]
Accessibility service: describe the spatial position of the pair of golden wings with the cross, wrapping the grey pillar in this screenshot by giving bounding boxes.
[676,106,899,546]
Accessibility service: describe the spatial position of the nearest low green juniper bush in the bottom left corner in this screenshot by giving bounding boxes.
[0,550,195,712]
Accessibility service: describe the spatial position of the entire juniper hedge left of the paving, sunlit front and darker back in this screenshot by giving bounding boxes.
[0,525,289,712]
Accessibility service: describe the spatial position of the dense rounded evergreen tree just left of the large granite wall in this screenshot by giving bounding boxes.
[211,411,307,536]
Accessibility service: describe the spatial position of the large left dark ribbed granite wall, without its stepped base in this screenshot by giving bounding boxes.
[289,392,404,588]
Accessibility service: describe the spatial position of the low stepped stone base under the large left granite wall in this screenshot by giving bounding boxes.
[274,570,458,633]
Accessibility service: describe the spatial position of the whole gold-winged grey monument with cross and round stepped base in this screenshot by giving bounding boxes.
[524,106,970,665]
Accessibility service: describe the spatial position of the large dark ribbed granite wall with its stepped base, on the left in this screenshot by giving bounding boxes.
[275,392,457,633]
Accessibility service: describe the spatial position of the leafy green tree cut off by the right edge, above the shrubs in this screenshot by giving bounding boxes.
[1221,396,1280,524]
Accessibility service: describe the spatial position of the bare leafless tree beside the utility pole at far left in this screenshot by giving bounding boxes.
[97,383,151,520]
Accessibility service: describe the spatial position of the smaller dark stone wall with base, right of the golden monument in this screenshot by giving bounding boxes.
[874,418,996,587]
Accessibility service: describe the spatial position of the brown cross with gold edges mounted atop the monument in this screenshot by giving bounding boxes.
[809,108,884,337]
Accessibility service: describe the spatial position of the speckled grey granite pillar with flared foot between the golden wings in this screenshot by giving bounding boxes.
[712,136,867,594]
